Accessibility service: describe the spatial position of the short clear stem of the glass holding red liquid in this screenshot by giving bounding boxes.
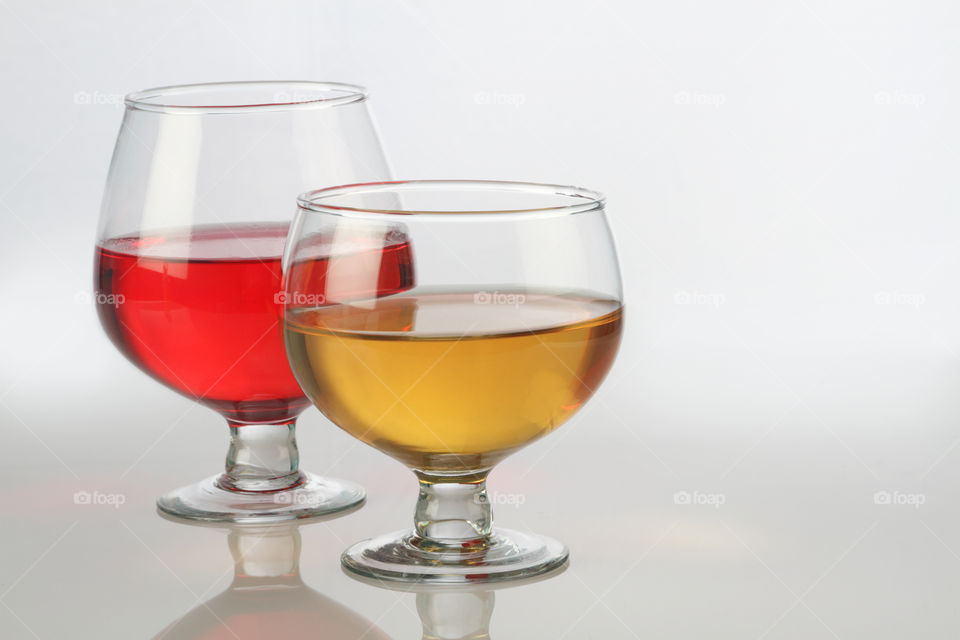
[218,419,303,491]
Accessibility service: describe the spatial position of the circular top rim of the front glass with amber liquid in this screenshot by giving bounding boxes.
[297,180,606,216]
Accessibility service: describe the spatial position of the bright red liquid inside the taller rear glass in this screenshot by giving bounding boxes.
[96,223,413,422]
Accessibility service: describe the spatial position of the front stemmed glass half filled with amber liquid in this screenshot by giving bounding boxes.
[284,180,623,584]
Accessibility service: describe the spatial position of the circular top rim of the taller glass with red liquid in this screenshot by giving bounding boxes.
[123,80,369,114]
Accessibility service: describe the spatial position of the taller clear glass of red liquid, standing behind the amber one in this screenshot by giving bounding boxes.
[94,81,389,522]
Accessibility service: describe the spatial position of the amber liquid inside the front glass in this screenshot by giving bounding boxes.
[284,292,622,473]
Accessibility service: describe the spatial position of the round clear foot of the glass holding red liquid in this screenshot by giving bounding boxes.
[157,472,366,523]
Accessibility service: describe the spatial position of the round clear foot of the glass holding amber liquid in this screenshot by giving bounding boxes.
[340,529,569,585]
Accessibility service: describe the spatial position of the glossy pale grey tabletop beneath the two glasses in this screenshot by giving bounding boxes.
[0,344,960,639]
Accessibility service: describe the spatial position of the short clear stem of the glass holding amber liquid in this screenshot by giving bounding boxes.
[414,471,493,547]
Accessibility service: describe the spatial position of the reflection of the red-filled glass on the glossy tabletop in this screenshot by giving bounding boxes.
[155,522,388,640]
